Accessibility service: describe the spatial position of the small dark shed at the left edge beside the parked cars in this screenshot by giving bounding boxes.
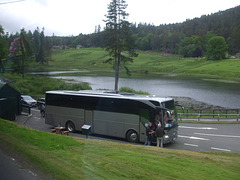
[0,82,21,121]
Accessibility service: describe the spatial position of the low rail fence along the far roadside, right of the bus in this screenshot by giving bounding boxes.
[178,109,239,121]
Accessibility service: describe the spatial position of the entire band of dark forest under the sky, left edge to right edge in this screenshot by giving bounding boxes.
[0,6,240,67]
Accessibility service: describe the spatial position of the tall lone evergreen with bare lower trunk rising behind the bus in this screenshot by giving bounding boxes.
[103,0,137,91]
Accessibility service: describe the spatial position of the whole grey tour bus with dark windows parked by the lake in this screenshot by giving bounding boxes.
[45,91,178,143]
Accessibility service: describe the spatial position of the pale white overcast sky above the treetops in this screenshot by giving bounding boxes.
[0,0,240,36]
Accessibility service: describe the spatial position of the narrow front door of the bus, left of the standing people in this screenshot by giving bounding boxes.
[139,109,150,142]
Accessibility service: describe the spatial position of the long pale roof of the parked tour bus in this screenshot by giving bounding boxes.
[46,90,173,103]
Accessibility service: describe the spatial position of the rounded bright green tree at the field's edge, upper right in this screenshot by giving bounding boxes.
[207,36,228,60]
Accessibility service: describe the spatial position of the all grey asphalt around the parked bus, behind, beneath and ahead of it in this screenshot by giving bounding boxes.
[16,109,240,153]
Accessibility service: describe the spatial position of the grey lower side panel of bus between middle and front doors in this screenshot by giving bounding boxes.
[94,111,139,138]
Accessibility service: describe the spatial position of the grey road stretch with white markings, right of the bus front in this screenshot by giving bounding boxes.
[169,123,240,153]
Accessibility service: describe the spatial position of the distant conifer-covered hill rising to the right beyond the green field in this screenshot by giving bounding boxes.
[49,6,240,57]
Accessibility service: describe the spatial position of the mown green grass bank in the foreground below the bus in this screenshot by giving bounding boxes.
[0,120,240,180]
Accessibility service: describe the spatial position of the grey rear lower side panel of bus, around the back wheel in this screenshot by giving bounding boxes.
[45,106,84,131]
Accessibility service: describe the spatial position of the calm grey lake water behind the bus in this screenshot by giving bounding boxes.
[55,76,240,108]
